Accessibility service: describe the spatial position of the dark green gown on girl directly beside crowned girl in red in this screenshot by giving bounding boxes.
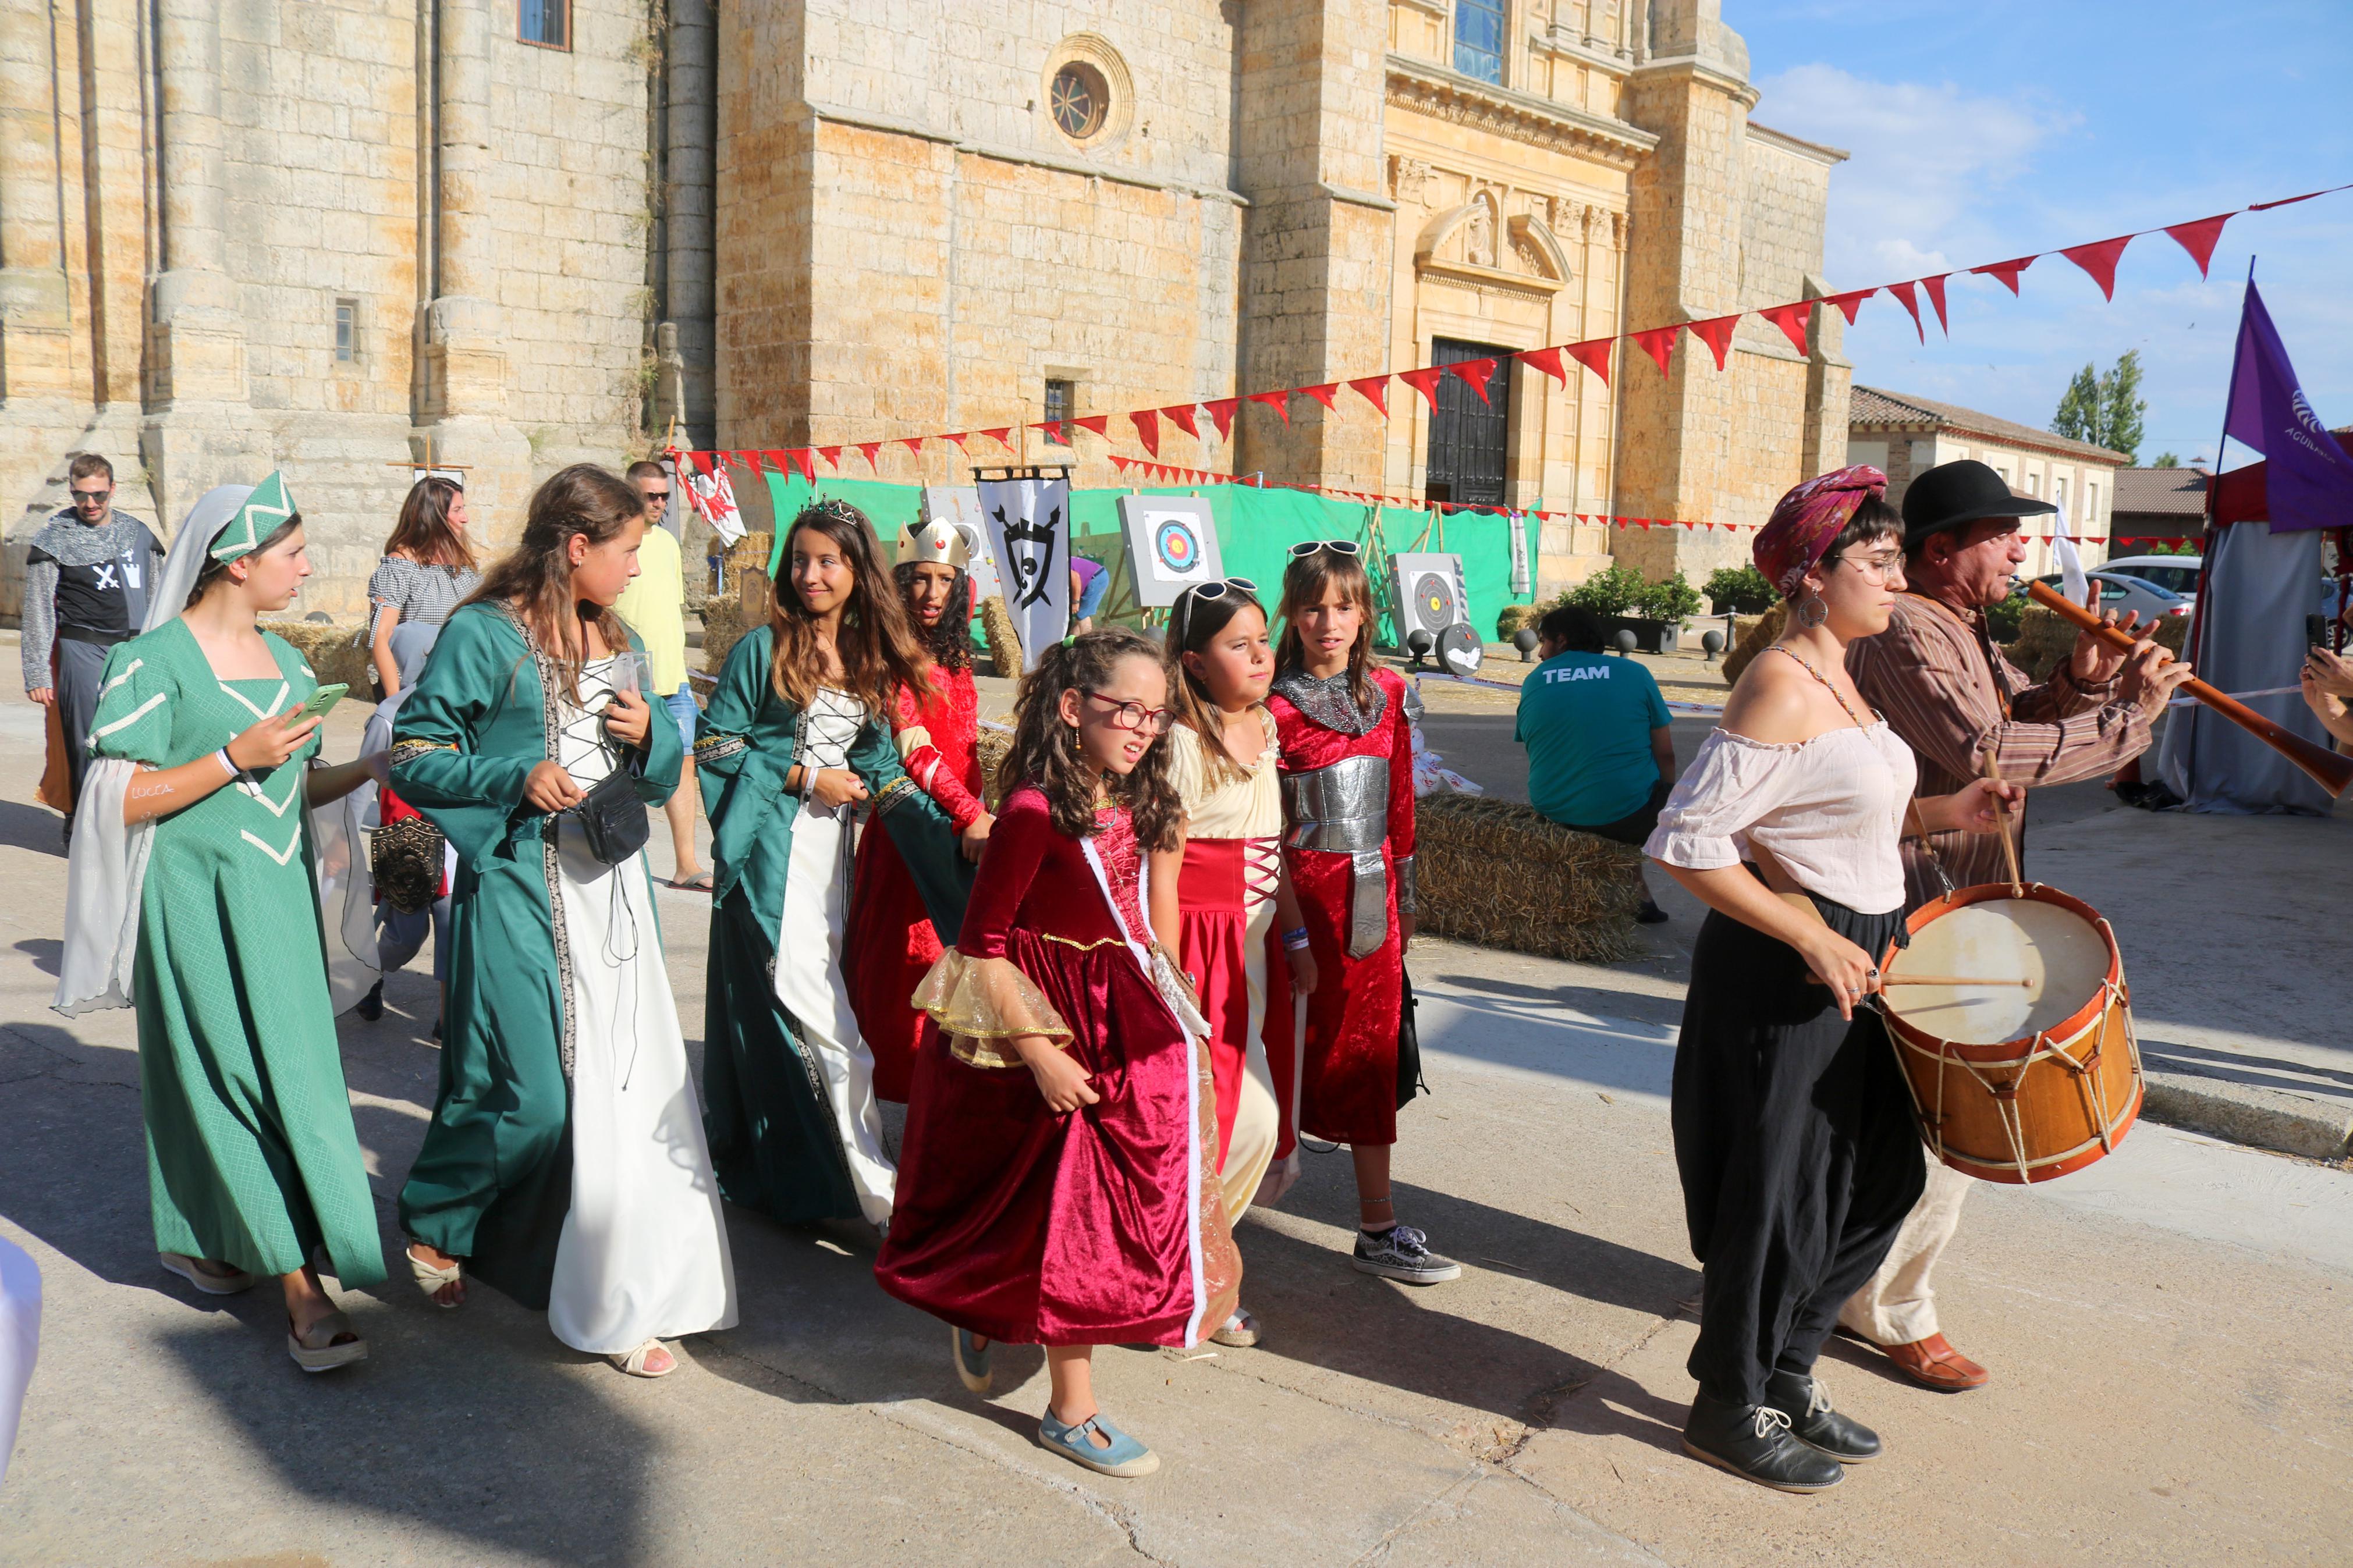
[694,625,972,1225]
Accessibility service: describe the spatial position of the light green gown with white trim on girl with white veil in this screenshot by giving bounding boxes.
[90,618,384,1288]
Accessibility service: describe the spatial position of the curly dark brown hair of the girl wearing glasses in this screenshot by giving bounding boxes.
[998,625,1184,849]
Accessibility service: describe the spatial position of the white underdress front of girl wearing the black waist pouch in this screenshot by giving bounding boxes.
[548,658,736,1354]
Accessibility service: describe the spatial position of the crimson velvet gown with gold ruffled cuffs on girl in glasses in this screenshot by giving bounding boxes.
[875,785,1243,1345]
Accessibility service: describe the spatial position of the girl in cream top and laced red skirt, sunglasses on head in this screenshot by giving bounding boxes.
[1151,578,1315,1345]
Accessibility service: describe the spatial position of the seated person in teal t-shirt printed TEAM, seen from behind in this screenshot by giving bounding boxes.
[1513,604,1676,924]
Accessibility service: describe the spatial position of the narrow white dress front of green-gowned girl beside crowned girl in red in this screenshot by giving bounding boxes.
[776,687,899,1225]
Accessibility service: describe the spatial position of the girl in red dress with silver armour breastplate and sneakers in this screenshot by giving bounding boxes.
[1266,541,1461,1286]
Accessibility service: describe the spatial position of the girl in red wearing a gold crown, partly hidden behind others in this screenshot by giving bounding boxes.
[842,522,995,1105]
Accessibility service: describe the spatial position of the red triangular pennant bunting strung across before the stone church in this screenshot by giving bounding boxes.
[682,183,2353,521]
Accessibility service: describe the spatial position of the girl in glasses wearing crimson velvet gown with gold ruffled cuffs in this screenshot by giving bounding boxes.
[875,630,1243,1476]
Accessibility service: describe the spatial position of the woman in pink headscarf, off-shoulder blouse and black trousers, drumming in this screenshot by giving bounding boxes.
[1645,468,2021,1493]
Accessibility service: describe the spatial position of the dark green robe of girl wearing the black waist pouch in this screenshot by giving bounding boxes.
[393,604,685,1310]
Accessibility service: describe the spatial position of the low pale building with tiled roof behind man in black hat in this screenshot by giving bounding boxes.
[1847,383,2132,576]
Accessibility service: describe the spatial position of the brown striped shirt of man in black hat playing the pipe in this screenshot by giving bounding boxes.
[1847,592,2155,908]
